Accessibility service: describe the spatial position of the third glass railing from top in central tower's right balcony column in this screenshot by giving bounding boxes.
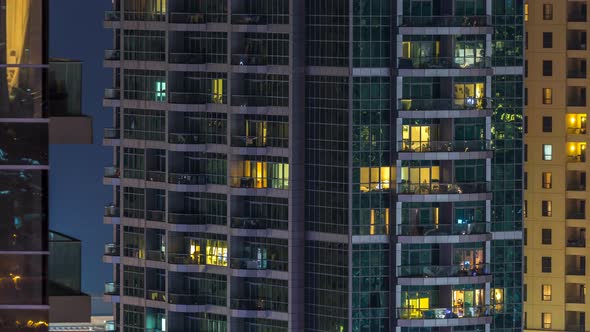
[398,97,492,111]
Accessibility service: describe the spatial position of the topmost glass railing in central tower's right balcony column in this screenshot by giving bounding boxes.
[398,16,492,27]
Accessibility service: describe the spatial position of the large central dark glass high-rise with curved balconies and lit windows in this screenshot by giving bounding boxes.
[104,0,524,332]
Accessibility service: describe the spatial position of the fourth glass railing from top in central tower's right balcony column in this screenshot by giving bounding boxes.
[398,140,491,152]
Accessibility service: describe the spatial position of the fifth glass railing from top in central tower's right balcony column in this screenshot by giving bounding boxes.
[397,182,491,195]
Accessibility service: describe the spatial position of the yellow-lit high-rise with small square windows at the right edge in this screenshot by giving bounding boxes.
[523,0,590,331]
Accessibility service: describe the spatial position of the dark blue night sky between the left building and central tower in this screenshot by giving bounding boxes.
[49,0,112,306]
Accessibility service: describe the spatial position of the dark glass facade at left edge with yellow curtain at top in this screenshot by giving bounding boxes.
[0,0,49,331]
